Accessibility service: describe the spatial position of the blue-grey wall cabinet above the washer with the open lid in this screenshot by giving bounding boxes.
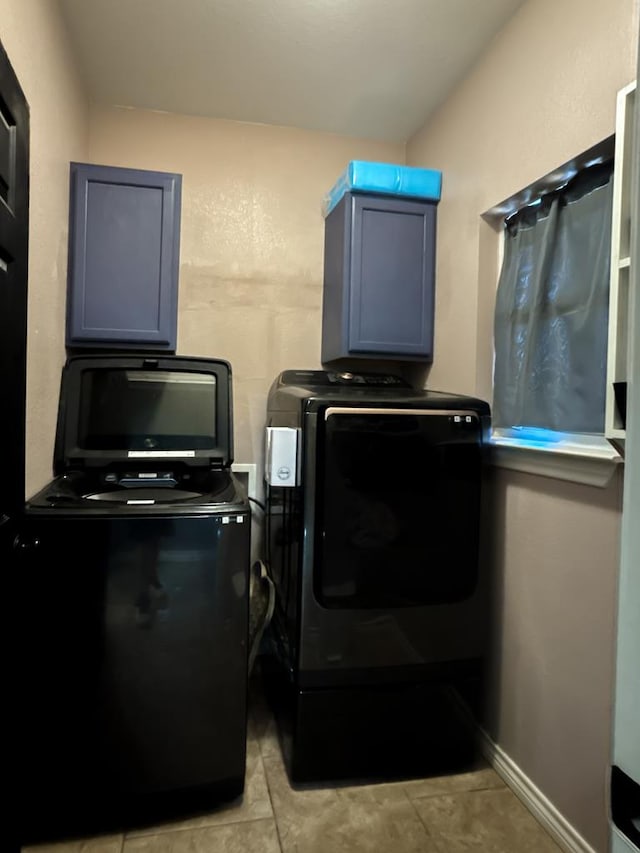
[67,163,182,352]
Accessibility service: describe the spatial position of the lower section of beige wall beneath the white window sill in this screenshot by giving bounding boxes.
[487,471,622,853]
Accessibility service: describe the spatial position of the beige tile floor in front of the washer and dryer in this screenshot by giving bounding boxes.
[23,682,560,853]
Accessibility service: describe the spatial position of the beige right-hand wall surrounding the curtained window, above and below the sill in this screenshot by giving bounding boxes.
[407,0,638,851]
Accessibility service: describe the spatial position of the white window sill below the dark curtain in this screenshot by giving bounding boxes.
[489,429,623,488]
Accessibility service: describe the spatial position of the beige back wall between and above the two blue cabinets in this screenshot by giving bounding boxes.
[89,107,404,472]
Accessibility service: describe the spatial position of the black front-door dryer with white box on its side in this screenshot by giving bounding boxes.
[266,370,491,782]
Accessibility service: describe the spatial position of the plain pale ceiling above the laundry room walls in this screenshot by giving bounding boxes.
[58,0,524,142]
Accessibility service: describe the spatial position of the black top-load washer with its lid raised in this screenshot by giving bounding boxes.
[16,354,250,842]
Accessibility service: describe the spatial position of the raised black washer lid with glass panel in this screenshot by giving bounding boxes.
[54,354,233,474]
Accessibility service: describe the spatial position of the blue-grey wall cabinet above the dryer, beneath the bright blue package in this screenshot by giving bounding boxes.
[322,193,437,364]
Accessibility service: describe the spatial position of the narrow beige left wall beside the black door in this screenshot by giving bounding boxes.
[0,0,88,495]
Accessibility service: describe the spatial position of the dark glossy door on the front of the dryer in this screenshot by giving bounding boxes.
[314,406,481,609]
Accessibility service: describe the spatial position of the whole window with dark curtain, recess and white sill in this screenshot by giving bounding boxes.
[485,140,619,485]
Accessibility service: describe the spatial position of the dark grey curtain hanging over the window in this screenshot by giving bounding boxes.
[493,165,612,433]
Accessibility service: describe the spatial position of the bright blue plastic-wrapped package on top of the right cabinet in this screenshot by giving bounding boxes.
[322,160,442,216]
